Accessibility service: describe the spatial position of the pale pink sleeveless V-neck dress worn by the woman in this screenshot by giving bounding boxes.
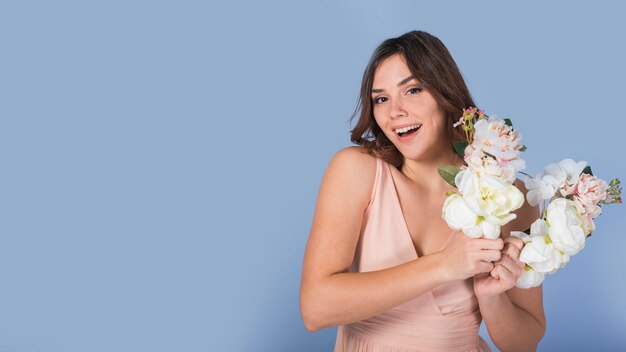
[334,158,491,352]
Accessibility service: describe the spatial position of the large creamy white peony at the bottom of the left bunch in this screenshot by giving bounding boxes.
[443,169,524,239]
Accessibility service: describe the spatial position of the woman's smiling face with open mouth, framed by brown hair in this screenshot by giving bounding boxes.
[372,54,450,160]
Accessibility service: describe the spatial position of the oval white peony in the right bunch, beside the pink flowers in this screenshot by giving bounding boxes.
[546,198,586,255]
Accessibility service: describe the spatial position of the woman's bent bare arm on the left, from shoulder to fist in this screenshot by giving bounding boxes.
[300,147,503,331]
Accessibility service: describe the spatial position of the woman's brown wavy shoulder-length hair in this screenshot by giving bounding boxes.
[350,31,476,168]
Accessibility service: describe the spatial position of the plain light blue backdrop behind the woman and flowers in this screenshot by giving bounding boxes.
[0,0,626,352]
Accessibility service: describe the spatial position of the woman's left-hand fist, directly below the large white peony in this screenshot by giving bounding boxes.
[439,232,504,280]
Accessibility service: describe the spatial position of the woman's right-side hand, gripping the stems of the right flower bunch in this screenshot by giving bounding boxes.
[474,236,525,299]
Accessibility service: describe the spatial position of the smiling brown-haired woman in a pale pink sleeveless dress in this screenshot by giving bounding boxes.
[300,31,545,351]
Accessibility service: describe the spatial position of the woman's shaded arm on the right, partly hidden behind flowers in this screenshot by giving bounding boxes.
[474,180,546,351]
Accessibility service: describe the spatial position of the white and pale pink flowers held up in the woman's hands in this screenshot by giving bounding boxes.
[439,108,622,288]
